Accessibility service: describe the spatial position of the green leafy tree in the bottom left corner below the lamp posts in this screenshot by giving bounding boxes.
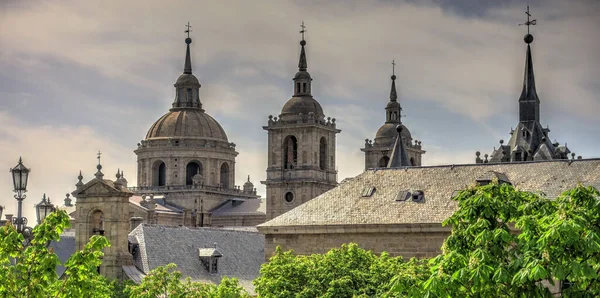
[0,211,113,298]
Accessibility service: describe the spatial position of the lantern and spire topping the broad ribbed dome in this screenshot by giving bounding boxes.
[171,22,202,110]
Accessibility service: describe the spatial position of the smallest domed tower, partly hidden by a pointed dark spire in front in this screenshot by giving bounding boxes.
[360,62,425,170]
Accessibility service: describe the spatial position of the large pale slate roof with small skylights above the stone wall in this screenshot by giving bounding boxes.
[258,159,600,230]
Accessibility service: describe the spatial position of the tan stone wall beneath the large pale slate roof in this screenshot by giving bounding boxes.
[259,225,450,260]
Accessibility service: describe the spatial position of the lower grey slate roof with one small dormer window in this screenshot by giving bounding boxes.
[129,224,265,293]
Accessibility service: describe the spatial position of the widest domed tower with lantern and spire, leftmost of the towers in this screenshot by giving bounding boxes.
[134,28,256,218]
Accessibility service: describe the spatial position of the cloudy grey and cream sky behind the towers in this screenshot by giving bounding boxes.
[0,0,600,222]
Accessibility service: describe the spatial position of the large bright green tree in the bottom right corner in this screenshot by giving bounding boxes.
[415,183,600,297]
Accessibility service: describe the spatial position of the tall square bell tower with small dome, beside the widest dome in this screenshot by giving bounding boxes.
[262,23,341,220]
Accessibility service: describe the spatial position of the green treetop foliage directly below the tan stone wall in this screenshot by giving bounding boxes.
[254,243,428,298]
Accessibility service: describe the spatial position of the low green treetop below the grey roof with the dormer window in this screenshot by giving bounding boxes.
[125,264,250,298]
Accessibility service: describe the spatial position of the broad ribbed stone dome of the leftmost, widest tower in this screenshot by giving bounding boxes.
[146,109,227,142]
